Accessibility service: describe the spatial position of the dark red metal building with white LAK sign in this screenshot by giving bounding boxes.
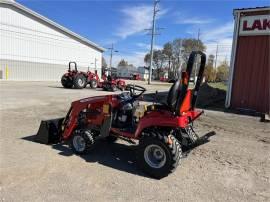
[226,7,270,114]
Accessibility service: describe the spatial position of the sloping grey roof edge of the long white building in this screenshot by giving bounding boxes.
[0,0,105,52]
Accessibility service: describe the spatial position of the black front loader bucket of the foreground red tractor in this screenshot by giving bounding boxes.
[35,118,64,144]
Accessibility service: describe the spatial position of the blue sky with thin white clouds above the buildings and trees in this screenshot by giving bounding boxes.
[17,0,269,66]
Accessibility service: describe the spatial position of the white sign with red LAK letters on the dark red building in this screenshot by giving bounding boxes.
[239,15,270,35]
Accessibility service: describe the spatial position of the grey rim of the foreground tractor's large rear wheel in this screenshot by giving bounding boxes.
[144,144,166,168]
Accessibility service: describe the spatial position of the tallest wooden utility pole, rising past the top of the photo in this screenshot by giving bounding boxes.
[148,0,159,84]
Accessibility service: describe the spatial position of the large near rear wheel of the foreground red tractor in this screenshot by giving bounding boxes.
[137,130,182,179]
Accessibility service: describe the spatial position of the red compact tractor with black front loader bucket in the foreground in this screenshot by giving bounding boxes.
[36,51,206,178]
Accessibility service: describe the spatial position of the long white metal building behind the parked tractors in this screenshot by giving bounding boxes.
[0,0,104,81]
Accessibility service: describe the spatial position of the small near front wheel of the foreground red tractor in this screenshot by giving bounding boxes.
[70,130,94,154]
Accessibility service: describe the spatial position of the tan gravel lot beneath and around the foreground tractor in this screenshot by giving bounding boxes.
[0,82,270,201]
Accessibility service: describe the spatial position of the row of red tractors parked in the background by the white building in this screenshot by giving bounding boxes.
[61,62,126,92]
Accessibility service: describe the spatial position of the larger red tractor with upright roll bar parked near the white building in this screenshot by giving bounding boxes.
[61,62,99,89]
